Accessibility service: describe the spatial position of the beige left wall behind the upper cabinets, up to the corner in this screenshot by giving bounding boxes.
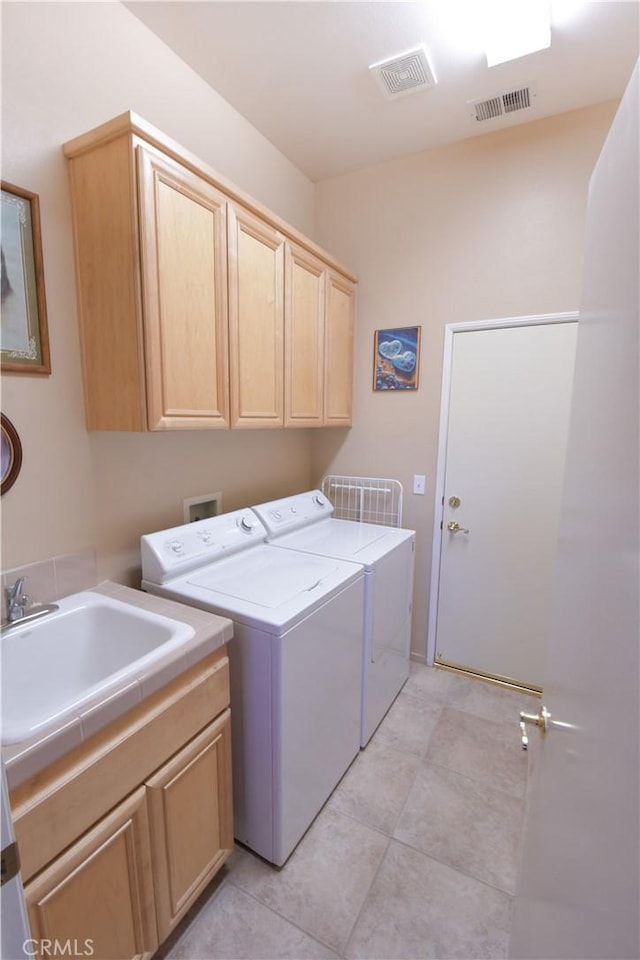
[2,3,314,581]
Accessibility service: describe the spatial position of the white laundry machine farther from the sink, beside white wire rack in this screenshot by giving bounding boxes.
[253,490,415,747]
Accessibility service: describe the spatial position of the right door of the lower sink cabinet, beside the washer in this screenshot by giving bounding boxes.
[147,710,233,942]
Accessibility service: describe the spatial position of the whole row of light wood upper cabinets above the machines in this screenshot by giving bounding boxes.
[64,113,355,430]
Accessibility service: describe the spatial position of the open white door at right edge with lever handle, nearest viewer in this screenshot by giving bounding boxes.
[509,60,640,960]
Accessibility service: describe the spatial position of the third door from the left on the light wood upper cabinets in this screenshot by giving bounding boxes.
[284,244,326,427]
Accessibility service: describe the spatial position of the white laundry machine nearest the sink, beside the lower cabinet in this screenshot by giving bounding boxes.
[141,510,364,866]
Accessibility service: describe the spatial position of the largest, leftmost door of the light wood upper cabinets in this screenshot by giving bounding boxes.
[137,146,229,430]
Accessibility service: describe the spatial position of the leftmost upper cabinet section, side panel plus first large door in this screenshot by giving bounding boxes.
[65,137,229,430]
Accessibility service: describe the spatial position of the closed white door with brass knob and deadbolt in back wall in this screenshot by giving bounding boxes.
[436,319,577,687]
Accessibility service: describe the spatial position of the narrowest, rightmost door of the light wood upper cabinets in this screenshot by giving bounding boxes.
[324,271,355,427]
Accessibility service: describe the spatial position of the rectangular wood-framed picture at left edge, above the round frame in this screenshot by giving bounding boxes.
[0,180,51,374]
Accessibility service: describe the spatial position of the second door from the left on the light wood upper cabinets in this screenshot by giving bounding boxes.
[228,206,284,427]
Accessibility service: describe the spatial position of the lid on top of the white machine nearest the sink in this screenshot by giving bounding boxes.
[187,549,339,610]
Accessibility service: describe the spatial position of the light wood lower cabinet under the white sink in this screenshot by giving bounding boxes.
[14,651,233,960]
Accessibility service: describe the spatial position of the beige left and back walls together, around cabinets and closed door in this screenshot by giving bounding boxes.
[2,3,615,655]
